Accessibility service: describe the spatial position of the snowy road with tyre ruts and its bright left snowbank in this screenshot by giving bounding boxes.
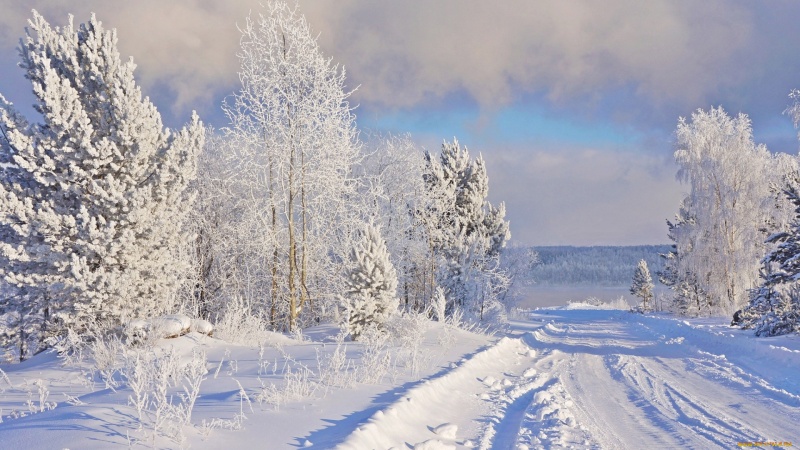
[328,310,800,449]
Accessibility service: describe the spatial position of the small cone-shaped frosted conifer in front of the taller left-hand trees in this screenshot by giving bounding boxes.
[342,224,398,340]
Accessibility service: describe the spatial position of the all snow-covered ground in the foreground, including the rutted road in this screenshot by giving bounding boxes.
[0,305,800,449]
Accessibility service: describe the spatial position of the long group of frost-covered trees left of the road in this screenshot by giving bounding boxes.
[0,1,527,359]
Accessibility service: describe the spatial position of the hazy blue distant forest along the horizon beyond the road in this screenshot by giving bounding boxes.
[532,245,671,286]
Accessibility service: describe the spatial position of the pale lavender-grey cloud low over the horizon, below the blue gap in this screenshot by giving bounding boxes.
[484,149,685,245]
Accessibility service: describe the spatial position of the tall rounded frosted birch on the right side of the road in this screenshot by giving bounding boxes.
[671,108,774,314]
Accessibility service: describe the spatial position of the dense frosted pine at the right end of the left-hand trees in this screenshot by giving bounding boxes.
[417,140,510,318]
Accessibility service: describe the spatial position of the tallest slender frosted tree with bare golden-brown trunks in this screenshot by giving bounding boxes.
[224,1,359,329]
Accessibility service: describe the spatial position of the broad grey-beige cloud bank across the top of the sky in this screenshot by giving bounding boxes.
[0,0,776,116]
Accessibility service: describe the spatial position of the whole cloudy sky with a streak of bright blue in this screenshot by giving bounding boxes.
[0,0,800,245]
